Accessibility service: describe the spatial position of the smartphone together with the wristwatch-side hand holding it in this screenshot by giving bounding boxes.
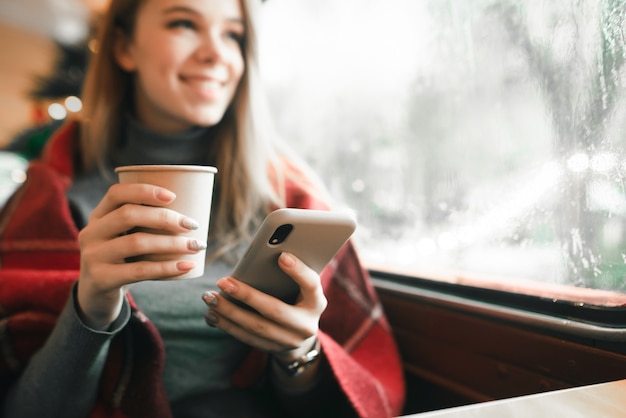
[203,209,356,385]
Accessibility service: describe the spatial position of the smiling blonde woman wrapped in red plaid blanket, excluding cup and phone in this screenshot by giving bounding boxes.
[0,0,404,417]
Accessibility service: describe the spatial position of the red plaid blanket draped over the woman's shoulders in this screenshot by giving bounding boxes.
[0,119,404,418]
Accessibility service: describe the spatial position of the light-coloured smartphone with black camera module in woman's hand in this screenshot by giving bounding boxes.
[232,209,356,304]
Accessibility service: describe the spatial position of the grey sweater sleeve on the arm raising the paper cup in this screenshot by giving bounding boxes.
[2,286,130,418]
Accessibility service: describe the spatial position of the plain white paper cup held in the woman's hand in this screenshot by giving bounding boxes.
[115,165,217,279]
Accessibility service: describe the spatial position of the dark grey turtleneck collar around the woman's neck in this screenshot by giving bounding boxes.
[111,116,217,166]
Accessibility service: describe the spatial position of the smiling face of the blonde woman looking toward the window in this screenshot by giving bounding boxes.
[116,0,245,133]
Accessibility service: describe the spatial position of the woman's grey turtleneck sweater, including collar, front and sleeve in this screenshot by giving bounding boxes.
[3,118,248,418]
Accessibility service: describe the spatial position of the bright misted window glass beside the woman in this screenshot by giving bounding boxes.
[261,0,626,304]
